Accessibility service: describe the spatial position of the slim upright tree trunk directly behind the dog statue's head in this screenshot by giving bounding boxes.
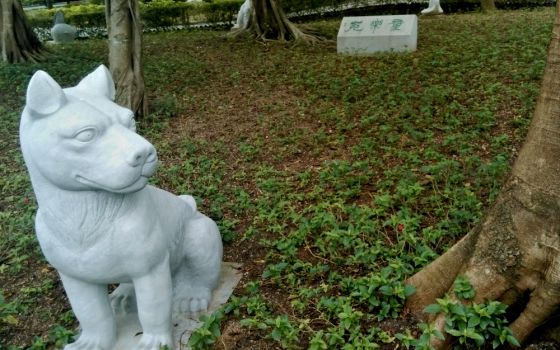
[105,0,147,118]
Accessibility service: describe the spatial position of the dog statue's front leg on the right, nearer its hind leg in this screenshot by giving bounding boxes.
[133,256,173,350]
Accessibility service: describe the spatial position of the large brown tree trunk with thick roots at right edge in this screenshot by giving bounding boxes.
[407,2,560,349]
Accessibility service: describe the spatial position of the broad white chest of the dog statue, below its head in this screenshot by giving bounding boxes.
[36,188,169,283]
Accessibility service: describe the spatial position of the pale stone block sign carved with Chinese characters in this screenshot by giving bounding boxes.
[336,15,418,55]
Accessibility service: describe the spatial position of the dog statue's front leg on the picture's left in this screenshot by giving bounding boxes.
[60,273,117,350]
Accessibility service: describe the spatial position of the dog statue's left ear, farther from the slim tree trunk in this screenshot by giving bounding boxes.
[26,70,66,115]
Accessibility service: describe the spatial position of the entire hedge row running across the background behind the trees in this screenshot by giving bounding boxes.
[27,0,556,28]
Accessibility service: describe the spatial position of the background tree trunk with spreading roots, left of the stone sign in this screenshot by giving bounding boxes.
[230,0,320,42]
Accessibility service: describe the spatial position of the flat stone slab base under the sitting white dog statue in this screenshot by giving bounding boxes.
[113,262,241,350]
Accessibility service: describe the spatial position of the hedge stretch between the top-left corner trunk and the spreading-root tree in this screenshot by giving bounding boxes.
[27,0,244,28]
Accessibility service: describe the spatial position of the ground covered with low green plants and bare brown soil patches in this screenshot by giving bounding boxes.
[0,8,554,349]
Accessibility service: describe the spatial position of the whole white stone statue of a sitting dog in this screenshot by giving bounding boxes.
[20,66,222,350]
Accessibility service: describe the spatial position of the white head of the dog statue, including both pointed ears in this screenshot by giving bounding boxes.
[20,65,157,193]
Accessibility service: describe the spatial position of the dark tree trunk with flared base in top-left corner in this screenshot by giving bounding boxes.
[0,0,43,63]
